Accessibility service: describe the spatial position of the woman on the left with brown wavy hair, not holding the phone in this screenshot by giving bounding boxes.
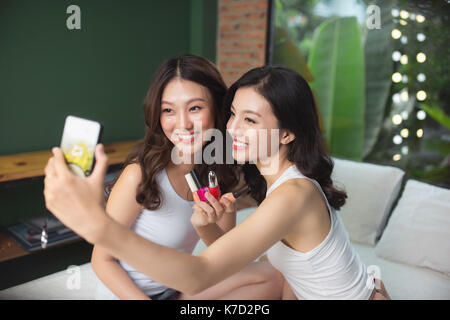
[79,55,282,300]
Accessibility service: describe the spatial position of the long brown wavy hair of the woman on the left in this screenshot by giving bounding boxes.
[122,55,239,210]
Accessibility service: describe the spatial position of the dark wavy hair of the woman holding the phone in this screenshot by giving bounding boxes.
[224,65,347,210]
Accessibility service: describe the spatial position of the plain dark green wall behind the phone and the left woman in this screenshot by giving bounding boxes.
[0,0,217,225]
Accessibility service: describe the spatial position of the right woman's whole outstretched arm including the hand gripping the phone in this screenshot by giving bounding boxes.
[44,146,312,294]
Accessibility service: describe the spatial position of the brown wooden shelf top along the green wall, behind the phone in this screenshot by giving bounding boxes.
[0,140,137,183]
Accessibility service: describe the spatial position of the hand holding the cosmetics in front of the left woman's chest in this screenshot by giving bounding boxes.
[191,192,236,227]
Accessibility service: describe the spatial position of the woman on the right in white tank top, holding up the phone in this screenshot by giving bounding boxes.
[44,66,389,300]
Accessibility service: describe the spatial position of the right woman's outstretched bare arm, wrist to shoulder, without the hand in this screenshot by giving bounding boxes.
[96,183,307,294]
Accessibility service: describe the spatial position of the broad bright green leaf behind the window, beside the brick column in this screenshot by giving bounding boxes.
[308,17,365,160]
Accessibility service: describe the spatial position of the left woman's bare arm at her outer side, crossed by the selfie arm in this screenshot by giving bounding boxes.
[91,164,149,300]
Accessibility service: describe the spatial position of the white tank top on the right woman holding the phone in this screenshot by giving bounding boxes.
[266,165,373,300]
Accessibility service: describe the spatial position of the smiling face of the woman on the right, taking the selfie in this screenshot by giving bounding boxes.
[227,87,280,163]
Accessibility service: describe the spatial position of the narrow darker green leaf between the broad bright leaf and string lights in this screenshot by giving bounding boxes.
[363,0,396,157]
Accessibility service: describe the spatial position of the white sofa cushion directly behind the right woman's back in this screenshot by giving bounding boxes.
[331,158,405,245]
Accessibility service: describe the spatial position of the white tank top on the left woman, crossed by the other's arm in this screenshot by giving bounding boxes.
[95,169,199,300]
